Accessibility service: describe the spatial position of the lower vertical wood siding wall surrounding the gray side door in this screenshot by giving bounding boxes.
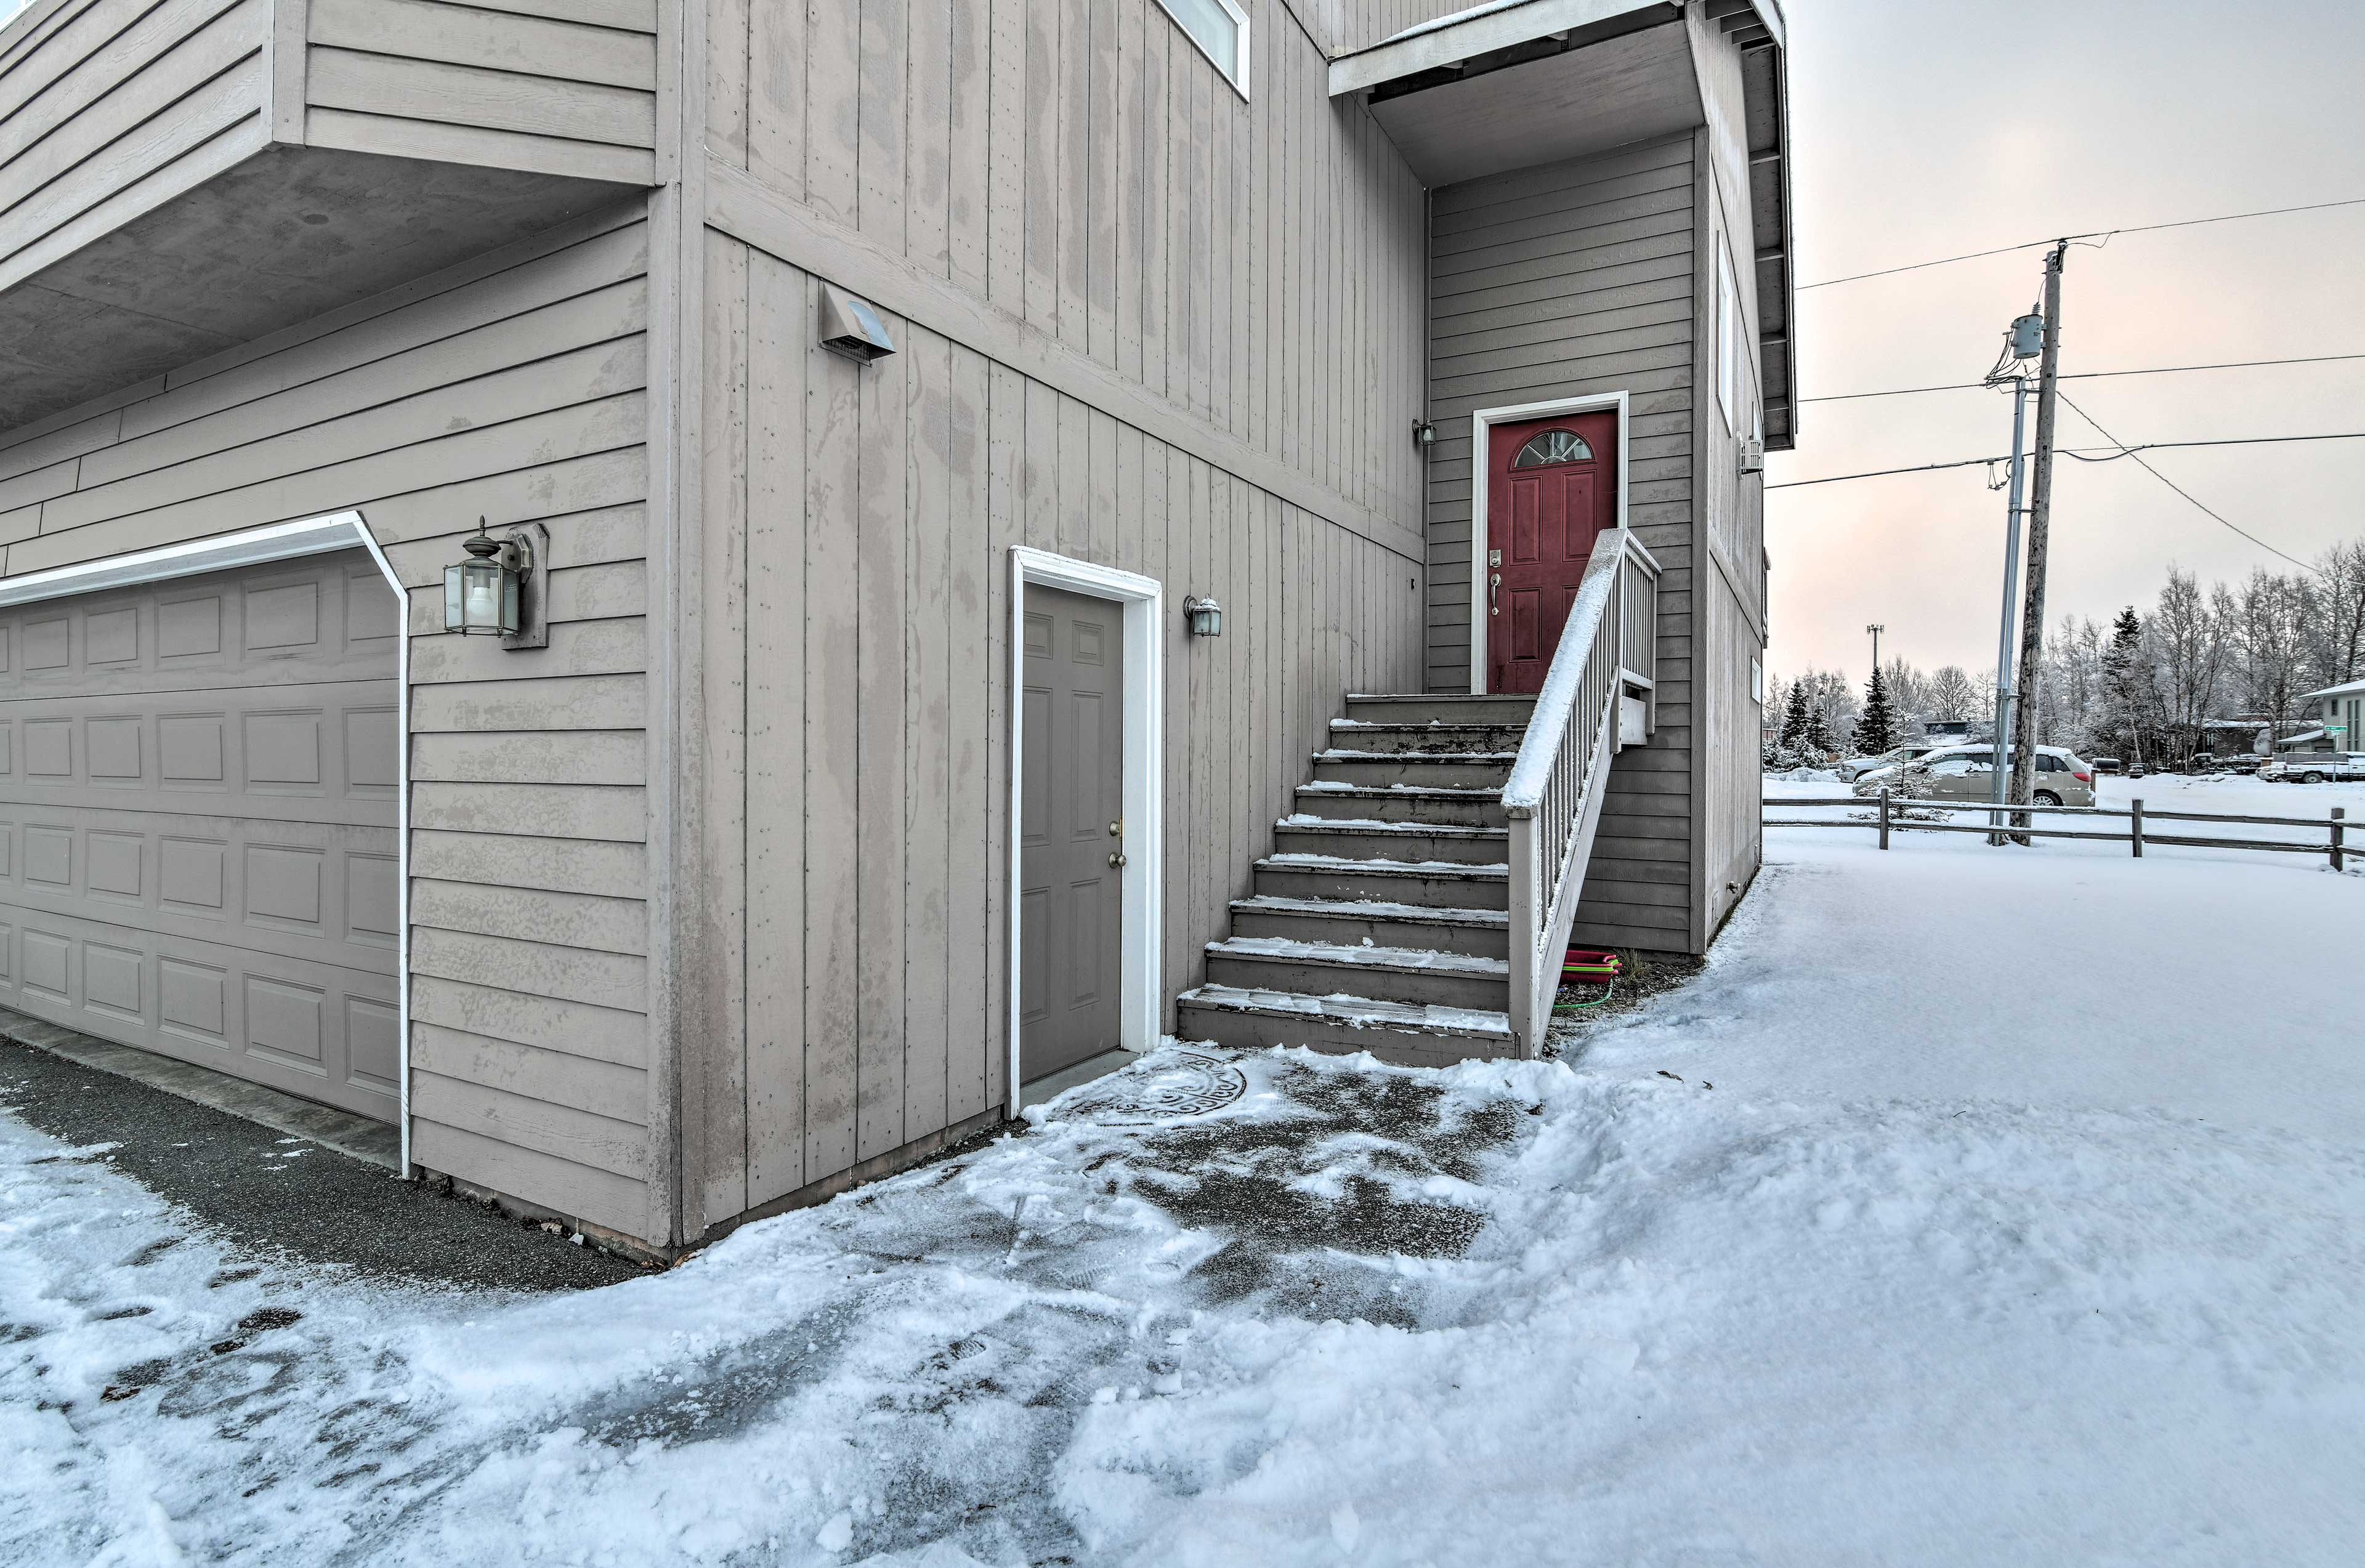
[684,232,1419,1232]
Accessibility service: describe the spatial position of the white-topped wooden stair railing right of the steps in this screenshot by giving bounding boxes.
[1502,527,1658,1057]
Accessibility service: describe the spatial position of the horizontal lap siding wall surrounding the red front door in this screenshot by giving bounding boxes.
[1424,135,1700,951]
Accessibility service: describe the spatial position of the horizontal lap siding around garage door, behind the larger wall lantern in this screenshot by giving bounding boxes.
[0,211,665,1237]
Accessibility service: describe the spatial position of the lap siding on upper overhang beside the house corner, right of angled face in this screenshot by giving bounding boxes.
[305,0,658,185]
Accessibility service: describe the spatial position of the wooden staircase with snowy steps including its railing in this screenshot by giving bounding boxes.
[1175,527,1660,1064]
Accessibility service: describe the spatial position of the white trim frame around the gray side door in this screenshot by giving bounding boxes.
[1005,544,1166,1117]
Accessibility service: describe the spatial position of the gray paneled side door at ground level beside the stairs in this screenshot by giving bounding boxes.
[1019,586,1126,1083]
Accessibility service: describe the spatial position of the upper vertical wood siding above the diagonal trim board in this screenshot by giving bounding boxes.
[707,0,1421,525]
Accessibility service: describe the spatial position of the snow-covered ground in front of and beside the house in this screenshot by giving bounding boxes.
[0,823,2365,1568]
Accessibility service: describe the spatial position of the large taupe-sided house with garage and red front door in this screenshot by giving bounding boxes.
[0,0,1795,1253]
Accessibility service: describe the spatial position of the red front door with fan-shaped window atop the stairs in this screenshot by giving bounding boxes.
[1481,411,1618,693]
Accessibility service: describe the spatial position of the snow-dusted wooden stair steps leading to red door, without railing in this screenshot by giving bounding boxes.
[1178,695,1535,1064]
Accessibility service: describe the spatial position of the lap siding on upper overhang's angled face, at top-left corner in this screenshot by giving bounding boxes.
[0,0,270,288]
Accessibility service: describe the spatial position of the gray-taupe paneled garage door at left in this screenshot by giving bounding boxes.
[0,551,400,1121]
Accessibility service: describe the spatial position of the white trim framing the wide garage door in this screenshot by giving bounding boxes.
[0,511,411,1176]
